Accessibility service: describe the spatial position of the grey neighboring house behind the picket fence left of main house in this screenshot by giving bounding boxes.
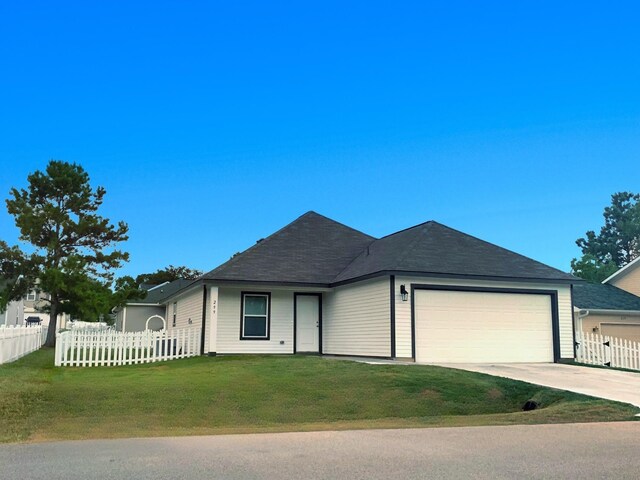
[114,279,193,332]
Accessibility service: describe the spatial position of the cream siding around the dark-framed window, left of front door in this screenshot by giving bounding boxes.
[215,287,293,354]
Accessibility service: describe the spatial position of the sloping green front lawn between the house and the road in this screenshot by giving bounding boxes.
[0,349,638,442]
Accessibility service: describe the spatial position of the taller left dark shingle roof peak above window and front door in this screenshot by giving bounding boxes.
[201,212,374,285]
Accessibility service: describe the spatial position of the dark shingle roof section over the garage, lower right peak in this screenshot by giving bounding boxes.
[334,221,578,282]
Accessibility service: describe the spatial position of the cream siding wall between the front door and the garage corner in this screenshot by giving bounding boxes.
[322,277,391,357]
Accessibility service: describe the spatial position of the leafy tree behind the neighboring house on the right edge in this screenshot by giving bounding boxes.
[571,192,640,281]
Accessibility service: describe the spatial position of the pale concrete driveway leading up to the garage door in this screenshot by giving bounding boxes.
[439,363,640,408]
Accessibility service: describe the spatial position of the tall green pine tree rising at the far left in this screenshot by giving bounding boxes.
[0,160,129,346]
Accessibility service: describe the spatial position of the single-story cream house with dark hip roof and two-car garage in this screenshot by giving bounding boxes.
[142,212,579,363]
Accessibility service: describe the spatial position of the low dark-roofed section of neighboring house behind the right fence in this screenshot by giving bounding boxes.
[573,283,640,342]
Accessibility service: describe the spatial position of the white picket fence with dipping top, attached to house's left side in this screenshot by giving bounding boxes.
[55,327,200,367]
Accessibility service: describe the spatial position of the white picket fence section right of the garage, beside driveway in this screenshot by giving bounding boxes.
[576,331,640,370]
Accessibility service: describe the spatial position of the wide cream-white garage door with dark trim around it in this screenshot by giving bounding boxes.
[414,290,553,363]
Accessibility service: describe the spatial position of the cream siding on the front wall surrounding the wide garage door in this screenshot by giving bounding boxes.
[395,276,574,358]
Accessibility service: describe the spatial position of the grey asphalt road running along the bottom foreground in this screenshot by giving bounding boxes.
[0,422,640,480]
